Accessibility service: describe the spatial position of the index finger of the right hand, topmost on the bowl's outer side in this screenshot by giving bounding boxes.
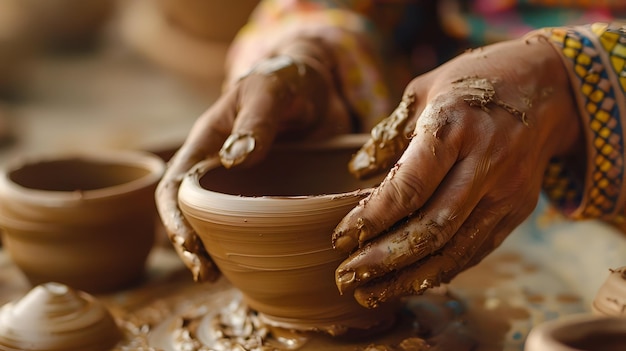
[333,105,461,252]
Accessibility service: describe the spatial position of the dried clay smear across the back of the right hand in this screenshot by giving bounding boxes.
[452,77,529,127]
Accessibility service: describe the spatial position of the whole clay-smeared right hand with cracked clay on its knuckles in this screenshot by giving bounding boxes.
[333,37,581,307]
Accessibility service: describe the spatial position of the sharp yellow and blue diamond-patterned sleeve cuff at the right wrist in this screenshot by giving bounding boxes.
[541,23,626,224]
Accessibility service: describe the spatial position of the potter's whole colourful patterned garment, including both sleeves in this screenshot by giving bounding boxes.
[228,0,626,222]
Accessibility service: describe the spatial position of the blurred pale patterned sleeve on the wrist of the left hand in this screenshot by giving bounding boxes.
[225,0,389,130]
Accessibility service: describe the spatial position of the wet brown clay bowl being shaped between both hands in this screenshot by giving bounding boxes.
[179,135,392,335]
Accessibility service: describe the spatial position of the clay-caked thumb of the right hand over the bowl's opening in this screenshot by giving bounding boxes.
[348,94,415,179]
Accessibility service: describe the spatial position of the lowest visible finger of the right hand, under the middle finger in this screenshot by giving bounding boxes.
[354,205,506,308]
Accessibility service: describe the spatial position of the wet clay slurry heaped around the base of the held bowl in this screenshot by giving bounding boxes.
[115,280,476,351]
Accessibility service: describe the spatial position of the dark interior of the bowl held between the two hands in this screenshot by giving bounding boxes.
[200,144,384,197]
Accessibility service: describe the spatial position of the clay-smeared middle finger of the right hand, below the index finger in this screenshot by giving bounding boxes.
[335,149,491,293]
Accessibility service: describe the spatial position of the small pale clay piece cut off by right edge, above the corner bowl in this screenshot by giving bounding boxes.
[591,267,626,318]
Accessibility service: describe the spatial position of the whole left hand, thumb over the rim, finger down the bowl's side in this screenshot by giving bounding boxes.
[156,40,352,281]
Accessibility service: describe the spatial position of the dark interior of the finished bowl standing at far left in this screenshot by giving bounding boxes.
[9,158,150,191]
